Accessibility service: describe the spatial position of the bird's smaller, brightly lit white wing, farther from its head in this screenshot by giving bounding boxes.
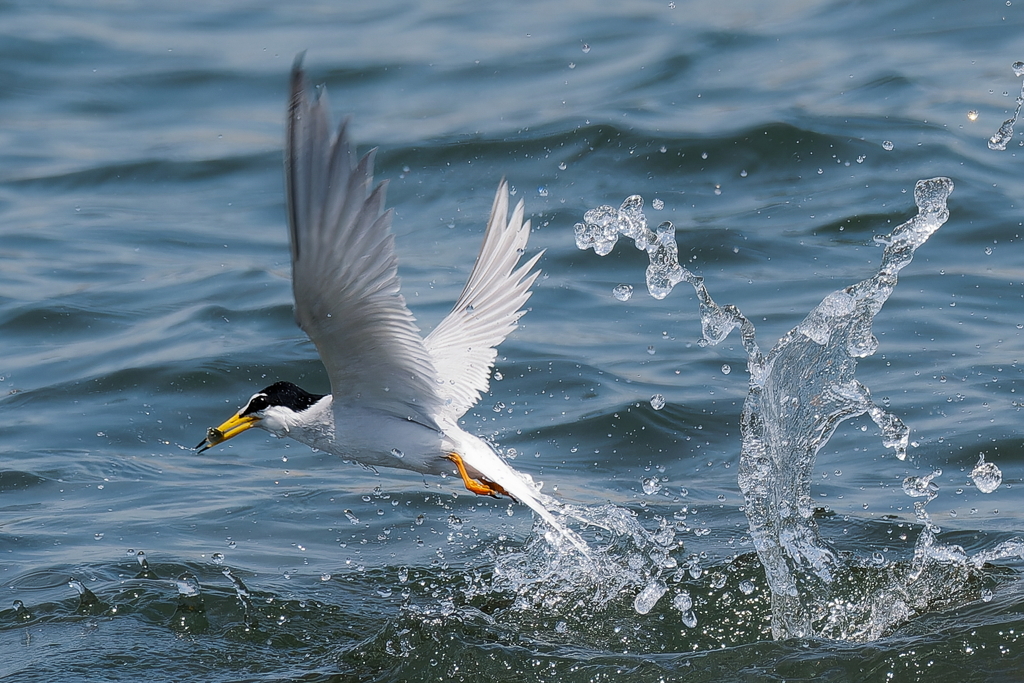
[424,179,543,418]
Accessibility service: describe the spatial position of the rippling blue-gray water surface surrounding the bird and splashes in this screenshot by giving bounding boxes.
[0,0,1024,681]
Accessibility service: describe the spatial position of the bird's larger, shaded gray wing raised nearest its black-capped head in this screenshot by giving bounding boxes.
[285,55,440,425]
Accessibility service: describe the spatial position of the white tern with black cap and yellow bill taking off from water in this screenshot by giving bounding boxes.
[196,54,586,550]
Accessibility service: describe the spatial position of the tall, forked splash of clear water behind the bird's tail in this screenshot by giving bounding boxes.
[575,177,1024,640]
